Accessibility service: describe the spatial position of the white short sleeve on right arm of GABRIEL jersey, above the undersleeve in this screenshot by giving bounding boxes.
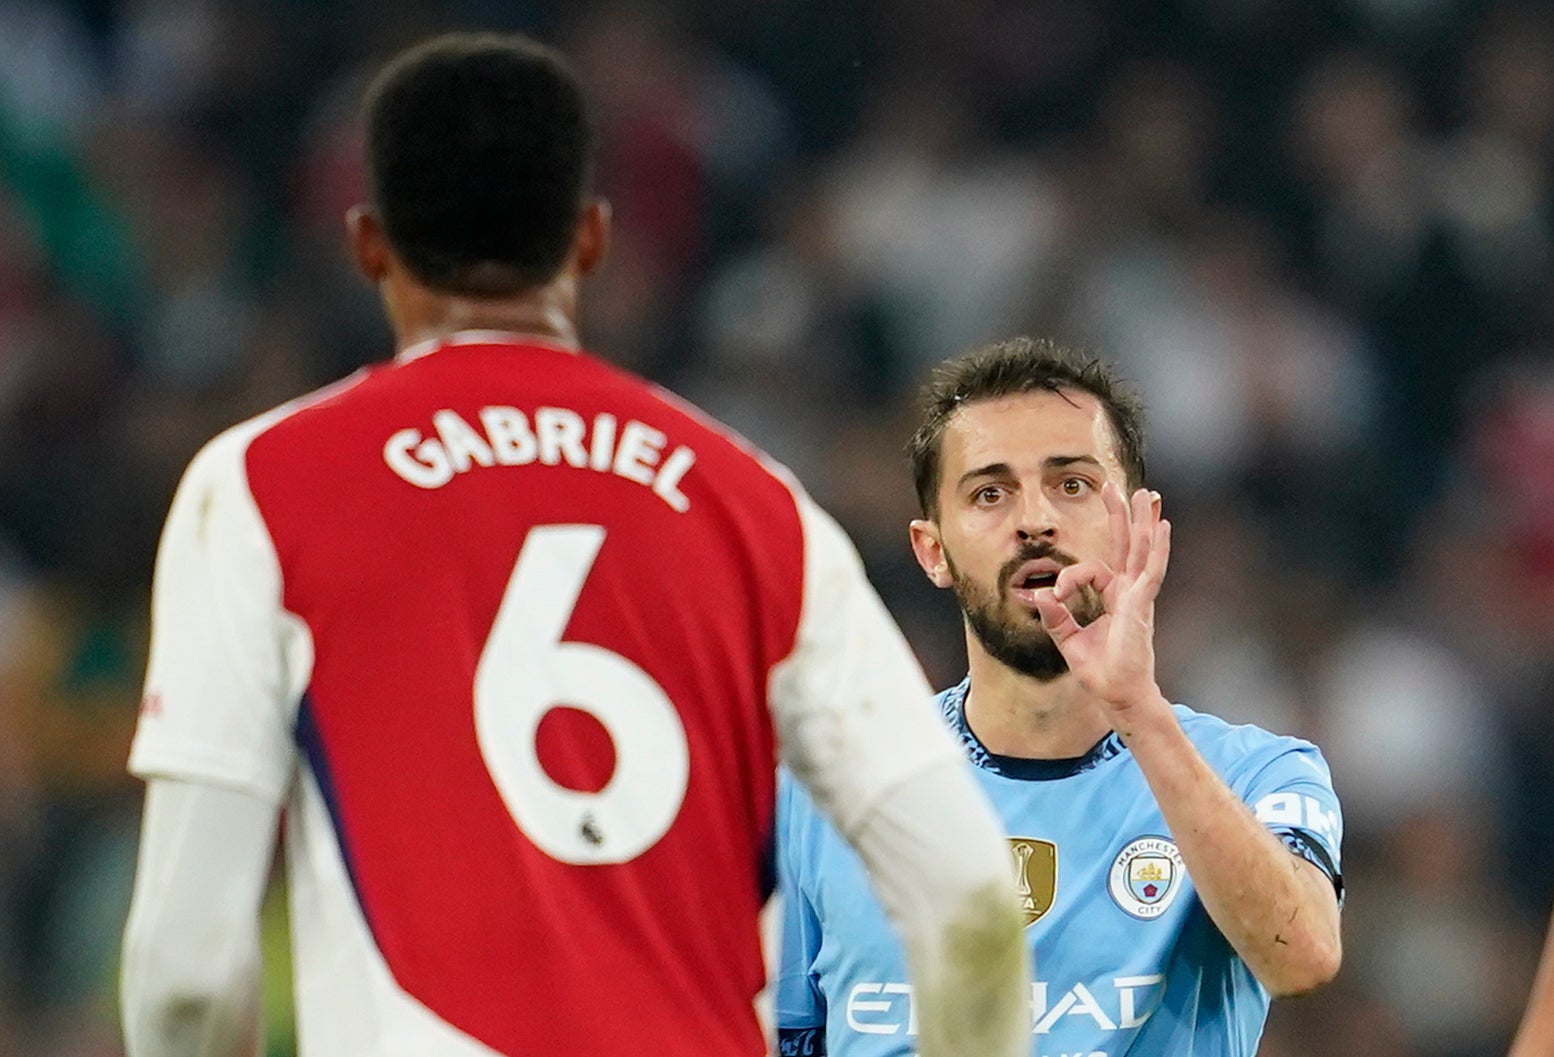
[769,493,960,836]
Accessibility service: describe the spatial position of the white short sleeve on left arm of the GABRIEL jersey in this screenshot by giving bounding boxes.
[129,420,312,804]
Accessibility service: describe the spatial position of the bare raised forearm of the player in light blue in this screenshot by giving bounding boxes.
[1122,699,1341,995]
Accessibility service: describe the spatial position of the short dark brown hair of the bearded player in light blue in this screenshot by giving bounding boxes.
[906,337,1144,518]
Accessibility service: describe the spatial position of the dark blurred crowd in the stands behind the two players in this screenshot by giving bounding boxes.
[0,0,1554,1057]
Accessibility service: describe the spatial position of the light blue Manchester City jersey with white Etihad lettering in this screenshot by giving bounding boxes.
[775,682,1341,1057]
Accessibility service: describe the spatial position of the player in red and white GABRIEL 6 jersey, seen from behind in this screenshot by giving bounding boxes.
[121,34,1029,1057]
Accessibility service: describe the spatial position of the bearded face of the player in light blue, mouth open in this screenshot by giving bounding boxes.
[912,390,1127,681]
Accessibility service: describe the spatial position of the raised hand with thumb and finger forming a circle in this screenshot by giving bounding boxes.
[1037,482,1170,731]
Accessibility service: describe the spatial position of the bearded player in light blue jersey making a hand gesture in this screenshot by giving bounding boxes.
[775,339,1343,1057]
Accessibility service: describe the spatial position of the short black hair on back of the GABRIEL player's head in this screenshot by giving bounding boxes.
[365,33,594,297]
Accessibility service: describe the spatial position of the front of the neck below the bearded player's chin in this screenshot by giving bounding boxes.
[967,631,1111,760]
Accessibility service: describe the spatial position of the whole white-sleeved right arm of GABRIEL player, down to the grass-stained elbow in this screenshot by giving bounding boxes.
[771,496,1030,1057]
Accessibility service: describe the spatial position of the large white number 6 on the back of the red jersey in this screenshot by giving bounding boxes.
[474,525,690,866]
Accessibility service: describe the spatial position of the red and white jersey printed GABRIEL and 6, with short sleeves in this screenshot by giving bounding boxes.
[131,334,943,1057]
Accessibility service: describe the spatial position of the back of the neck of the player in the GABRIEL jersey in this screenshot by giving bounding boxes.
[382,274,578,350]
